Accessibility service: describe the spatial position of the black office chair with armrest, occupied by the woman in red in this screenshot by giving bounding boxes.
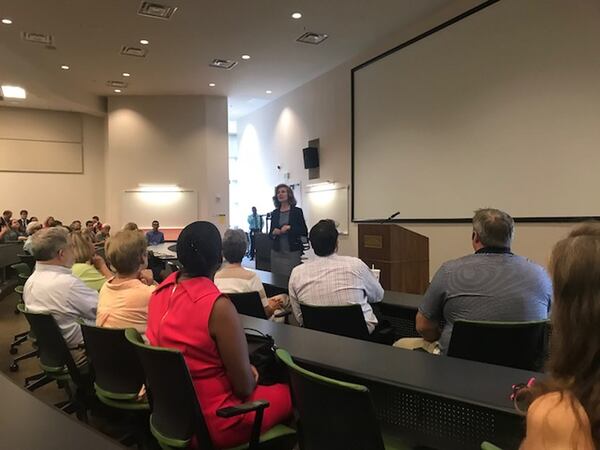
[125,328,296,450]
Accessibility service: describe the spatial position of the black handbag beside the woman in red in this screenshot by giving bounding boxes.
[244,328,285,386]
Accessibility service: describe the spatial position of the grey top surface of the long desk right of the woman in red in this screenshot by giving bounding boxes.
[242,316,541,415]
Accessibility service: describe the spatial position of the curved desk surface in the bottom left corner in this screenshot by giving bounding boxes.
[0,373,125,450]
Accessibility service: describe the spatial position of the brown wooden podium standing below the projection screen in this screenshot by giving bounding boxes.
[358,223,429,294]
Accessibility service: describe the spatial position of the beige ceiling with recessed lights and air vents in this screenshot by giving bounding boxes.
[0,0,449,119]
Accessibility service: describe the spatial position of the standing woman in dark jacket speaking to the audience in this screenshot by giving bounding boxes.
[269,184,308,276]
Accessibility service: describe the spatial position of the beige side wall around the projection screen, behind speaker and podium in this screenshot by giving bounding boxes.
[238,0,570,276]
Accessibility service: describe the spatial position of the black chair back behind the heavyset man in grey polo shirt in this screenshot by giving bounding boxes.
[447,320,549,371]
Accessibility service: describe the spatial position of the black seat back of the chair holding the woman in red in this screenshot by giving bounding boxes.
[125,328,213,450]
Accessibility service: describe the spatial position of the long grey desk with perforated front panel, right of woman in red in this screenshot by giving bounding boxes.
[241,316,542,450]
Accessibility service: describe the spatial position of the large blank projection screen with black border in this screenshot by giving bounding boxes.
[352,0,600,222]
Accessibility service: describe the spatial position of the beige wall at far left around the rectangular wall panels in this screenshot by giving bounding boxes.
[0,107,106,224]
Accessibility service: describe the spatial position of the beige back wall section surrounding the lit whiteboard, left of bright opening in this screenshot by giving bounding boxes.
[106,96,229,229]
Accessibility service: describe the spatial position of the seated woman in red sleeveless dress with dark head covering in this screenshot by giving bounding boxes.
[146,222,292,448]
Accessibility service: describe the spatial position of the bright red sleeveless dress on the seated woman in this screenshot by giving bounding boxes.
[146,273,292,448]
